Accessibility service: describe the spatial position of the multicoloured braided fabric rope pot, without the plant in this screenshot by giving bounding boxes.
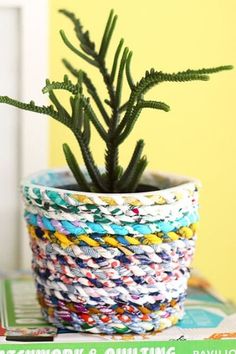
[22,170,199,334]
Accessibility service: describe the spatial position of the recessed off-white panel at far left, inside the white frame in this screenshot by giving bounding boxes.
[0,7,20,269]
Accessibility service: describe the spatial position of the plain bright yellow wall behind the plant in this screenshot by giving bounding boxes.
[49,0,236,301]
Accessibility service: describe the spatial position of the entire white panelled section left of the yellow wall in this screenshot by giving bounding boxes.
[0,0,48,271]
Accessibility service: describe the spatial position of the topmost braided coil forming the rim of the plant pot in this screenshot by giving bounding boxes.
[21,170,199,209]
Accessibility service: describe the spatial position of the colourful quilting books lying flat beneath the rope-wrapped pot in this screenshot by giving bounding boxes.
[0,275,236,354]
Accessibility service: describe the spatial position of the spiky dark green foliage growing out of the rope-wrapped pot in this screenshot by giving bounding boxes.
[0,10,232,192]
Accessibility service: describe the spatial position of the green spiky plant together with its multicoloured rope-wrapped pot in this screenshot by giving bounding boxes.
[0,10,232,334]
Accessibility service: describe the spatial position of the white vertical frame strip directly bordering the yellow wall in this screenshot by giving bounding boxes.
[0,0,48,268]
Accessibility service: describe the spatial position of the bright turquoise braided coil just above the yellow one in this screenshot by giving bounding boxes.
[25,211,199,235]
